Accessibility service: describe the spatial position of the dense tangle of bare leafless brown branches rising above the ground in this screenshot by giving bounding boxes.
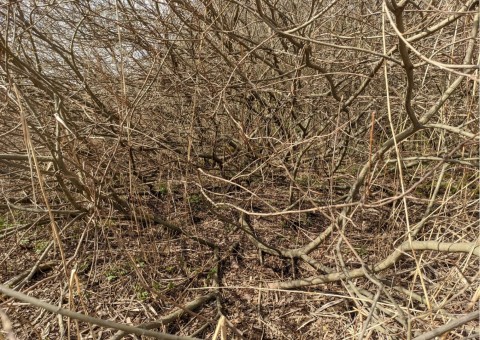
[0,0,478,338]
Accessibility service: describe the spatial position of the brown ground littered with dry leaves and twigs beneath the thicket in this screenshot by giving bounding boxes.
[0,169,480,339]
